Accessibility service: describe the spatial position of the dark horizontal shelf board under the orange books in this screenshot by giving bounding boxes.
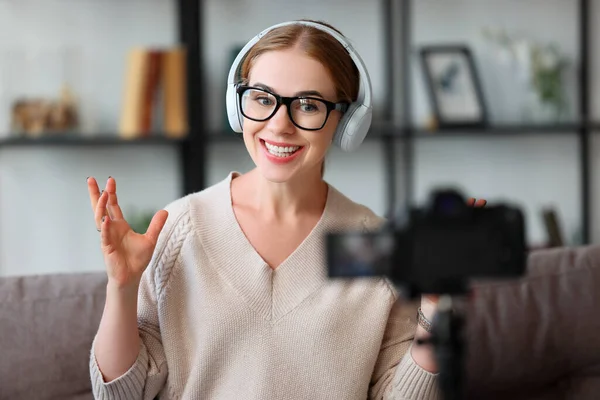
[0,134,186,148]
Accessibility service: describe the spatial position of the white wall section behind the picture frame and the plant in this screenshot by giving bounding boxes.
[412,0,579,123]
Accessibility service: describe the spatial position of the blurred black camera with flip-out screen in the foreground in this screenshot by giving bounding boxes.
[326,189,527,298]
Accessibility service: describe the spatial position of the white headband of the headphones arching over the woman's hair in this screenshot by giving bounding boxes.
[227,21,372,108]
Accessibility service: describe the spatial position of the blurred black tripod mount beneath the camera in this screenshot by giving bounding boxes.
[417,296,465,400]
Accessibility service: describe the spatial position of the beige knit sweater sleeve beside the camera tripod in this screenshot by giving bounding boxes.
[369,288,441,400]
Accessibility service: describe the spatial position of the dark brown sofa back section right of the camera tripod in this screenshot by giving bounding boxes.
[467,246,600,398]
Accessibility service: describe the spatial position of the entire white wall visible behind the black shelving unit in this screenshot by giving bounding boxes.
[0,0,600,275]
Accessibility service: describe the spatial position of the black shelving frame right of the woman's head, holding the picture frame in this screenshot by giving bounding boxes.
[383,0,600,244]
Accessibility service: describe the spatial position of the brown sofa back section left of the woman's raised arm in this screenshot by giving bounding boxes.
[0,272,106,400]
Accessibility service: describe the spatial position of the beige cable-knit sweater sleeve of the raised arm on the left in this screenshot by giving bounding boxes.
[90,204,190,400]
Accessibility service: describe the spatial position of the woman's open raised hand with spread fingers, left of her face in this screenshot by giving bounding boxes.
[87,177,168,289]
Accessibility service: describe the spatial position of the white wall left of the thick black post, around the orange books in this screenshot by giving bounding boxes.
[0,0,181,275]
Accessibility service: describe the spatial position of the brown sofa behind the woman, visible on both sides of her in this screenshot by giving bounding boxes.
[0,246,600,400]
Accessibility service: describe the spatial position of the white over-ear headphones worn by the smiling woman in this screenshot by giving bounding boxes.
[225,21,373,151]
